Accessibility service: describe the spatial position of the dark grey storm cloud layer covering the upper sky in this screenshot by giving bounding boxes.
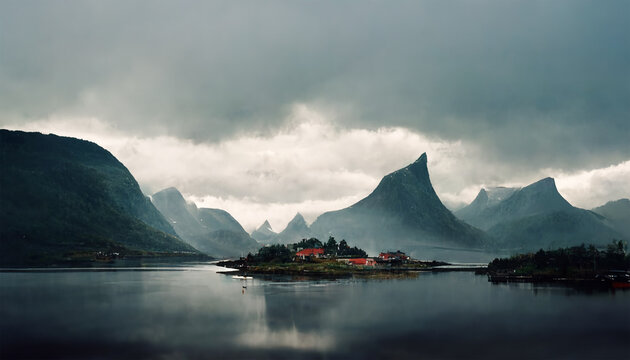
[0,1,630,169]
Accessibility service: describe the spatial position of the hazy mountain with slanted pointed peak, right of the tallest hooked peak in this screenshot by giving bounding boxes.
[457,178,621,250]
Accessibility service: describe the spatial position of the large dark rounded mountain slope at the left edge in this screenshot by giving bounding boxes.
[0,130,198,264]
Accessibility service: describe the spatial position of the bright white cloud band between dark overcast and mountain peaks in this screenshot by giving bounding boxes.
[9,104,630,231]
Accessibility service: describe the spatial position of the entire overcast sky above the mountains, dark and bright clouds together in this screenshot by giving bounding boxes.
[0,0,630,230]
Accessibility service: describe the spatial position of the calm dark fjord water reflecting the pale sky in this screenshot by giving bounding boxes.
[0,265,630,359]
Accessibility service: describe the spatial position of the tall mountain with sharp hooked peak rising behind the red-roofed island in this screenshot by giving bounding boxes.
[311,153,485,256]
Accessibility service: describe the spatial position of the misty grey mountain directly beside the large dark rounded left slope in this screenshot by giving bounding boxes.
[151,187,260,257]
